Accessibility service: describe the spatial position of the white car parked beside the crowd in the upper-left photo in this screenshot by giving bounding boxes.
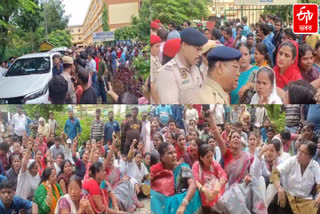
[0,52,60,104]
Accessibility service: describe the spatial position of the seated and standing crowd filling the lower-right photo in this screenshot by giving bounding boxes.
[146,104,320,214]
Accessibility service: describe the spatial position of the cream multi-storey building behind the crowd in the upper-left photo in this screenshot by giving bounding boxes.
[69,0,141,46]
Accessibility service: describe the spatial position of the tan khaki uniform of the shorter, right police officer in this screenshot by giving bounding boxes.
[194,78,230,104]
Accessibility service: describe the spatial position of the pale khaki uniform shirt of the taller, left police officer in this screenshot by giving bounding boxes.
[156,55,202,104]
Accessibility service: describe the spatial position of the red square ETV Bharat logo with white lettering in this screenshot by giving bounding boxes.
[293,4,318,34]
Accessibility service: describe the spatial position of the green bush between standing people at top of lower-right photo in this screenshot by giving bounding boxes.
[264,105,286,133]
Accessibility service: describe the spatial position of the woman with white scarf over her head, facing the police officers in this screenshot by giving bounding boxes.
[250,67,282,104]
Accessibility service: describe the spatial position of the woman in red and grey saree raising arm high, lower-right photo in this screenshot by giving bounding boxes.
[208,111,267,214]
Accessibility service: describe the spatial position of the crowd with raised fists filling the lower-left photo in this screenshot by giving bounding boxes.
[0,107,150,214]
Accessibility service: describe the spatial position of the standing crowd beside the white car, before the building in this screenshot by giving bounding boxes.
[49,43,150,104]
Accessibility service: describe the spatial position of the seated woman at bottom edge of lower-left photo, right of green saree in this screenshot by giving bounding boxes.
[55,175,94,214]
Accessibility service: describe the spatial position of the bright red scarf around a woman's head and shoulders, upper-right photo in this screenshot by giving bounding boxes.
[273,40,302,89]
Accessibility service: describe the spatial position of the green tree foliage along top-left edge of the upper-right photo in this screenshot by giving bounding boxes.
[151,0,209,24]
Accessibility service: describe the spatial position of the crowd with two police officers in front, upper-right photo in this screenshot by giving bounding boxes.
[150,15,320,104]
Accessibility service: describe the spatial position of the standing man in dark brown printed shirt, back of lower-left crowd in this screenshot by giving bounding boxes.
[124,107,142,155]
